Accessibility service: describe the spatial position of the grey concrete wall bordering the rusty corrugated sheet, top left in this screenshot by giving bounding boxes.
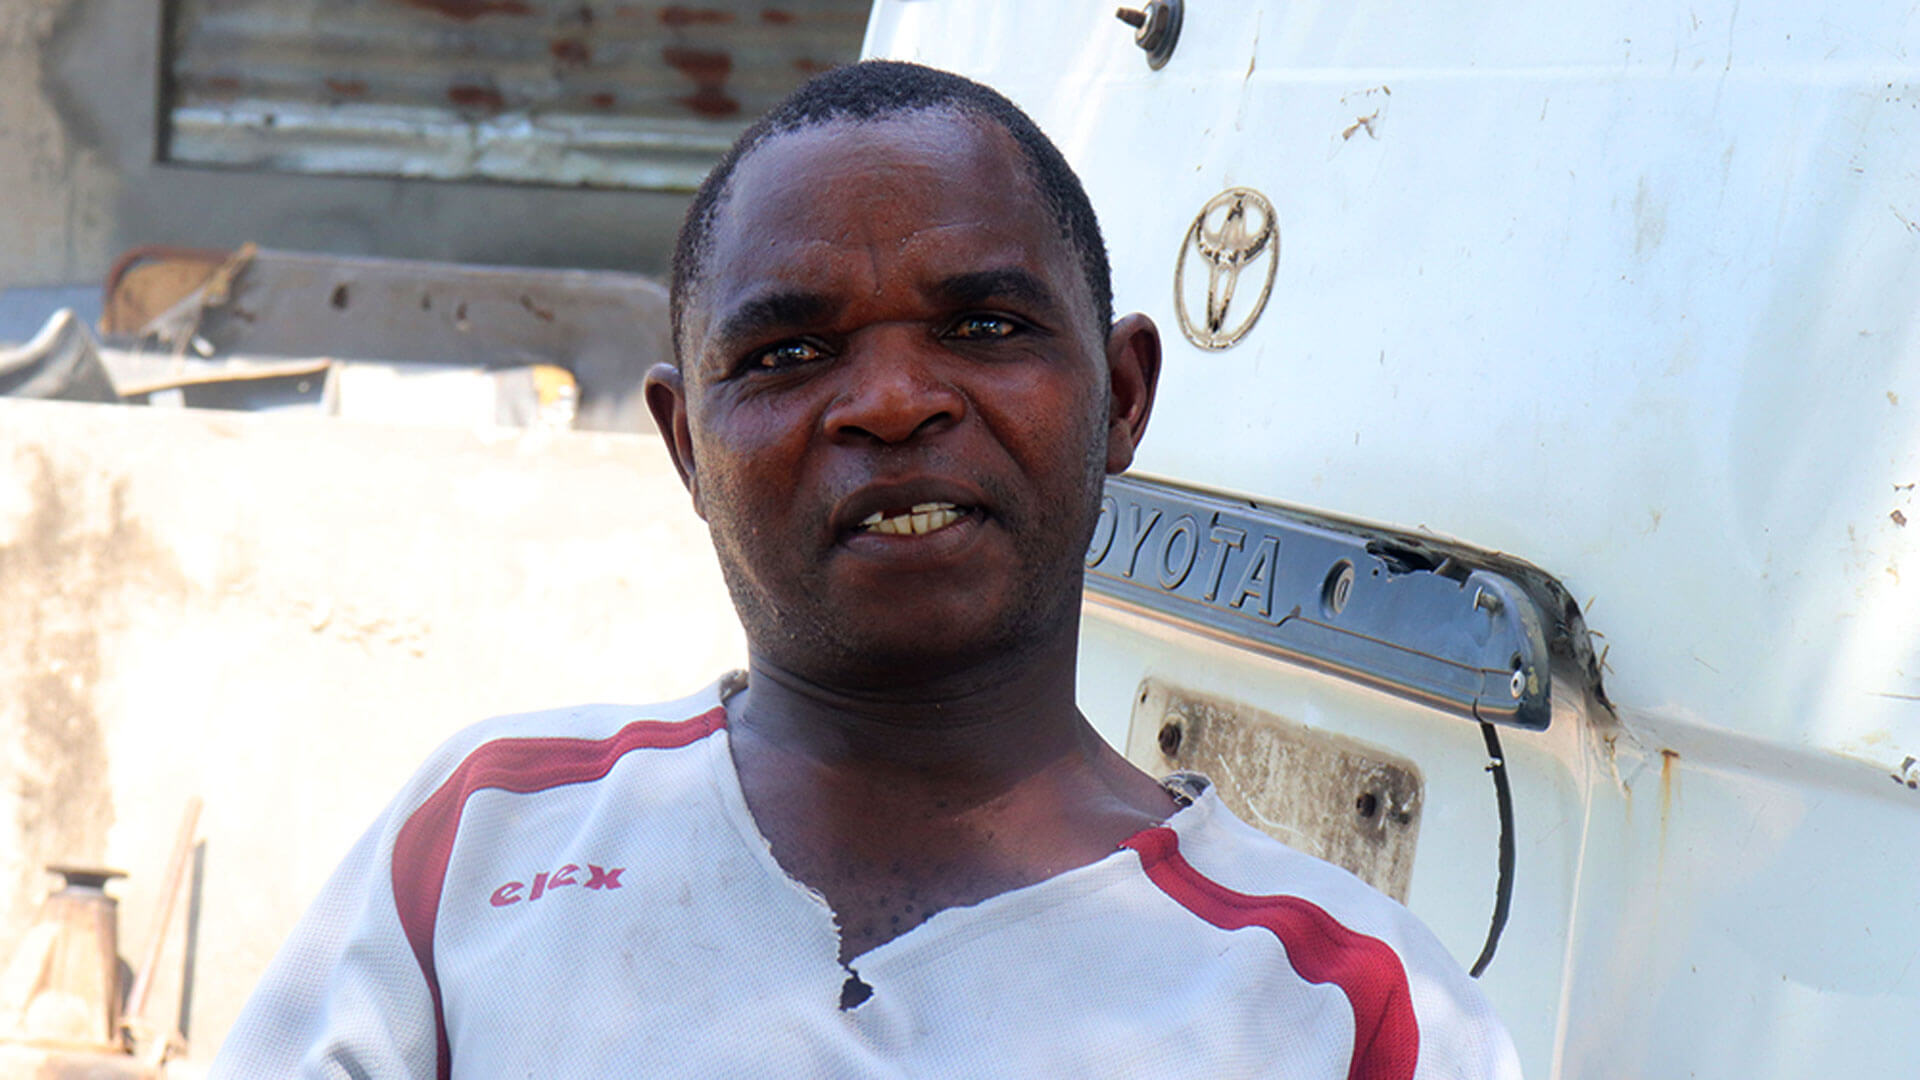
[0,0,687,288]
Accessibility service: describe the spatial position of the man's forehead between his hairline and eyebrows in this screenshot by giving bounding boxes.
[693,111,1092,334]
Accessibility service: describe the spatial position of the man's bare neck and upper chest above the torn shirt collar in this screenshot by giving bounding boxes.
[728,625,1175,963]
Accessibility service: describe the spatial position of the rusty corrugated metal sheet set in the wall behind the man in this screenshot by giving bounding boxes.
[167,0,868,190]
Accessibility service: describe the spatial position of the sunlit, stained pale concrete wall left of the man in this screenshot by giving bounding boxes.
[0,400,745,1074]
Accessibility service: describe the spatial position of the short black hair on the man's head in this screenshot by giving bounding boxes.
[670,60,1114,361]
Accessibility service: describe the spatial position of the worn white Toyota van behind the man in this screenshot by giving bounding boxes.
[866,0,1920,1080]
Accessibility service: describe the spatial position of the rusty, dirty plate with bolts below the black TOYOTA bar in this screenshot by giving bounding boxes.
[1127,678,1425,903]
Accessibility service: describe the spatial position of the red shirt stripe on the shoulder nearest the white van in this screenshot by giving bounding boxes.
[1121,826,1421,1080]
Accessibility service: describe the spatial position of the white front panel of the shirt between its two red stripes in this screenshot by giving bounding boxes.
[434,780,1352,1076]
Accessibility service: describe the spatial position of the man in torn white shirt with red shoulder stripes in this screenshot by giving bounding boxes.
[215,63,1517,1080]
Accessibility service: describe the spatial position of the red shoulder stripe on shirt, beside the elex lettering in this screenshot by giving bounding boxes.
[394,705,726,1080]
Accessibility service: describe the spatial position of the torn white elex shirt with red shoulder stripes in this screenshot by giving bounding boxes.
[213,676,1519,1080]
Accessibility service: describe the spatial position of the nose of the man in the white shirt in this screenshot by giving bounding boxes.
[824,327,968,446]
